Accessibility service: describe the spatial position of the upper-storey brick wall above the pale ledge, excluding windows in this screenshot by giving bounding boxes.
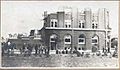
[44,8,109,29]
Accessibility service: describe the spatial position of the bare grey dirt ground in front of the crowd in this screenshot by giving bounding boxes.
[2,54,118,67]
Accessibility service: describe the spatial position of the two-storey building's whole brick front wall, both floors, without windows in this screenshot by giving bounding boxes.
[41,8,108,50]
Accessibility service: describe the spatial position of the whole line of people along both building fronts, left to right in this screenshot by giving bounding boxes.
[2,42,118,57]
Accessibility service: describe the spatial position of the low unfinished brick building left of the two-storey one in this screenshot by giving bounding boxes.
[6,30,42,49]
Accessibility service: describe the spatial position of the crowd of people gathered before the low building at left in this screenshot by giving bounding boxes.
[2,43,47,56]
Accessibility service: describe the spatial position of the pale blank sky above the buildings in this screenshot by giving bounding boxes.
[1,1,119,38]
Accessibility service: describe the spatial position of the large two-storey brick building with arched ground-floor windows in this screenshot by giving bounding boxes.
[41,8,111,52]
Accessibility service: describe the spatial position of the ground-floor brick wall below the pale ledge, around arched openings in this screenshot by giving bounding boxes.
[45,29,105,50]
